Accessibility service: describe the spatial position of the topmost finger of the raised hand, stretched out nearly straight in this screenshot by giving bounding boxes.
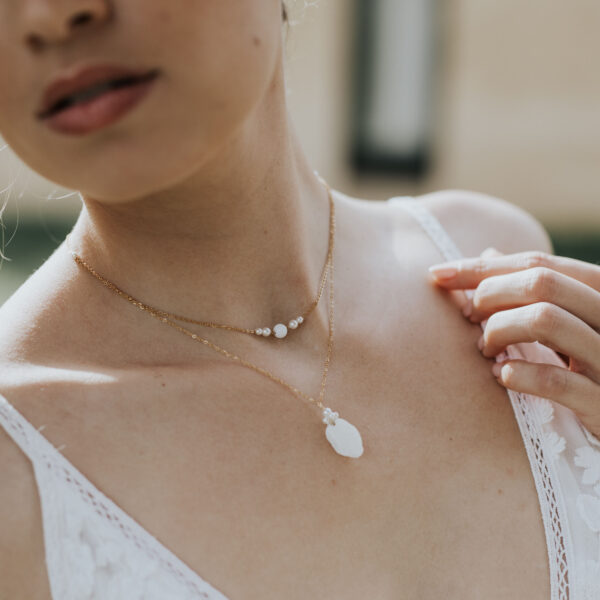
[429,250,600,292]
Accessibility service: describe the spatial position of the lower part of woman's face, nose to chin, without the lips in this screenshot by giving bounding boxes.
[0,0,281,200]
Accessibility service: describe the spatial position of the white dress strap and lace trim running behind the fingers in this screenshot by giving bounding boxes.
[388,196,574,600]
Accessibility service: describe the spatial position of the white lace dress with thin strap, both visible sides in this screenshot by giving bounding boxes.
[0,197,600,600]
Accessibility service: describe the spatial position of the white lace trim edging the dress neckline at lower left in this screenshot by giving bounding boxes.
[0,395,228,600]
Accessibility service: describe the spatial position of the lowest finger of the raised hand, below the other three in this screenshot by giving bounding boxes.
[492,359,600,426]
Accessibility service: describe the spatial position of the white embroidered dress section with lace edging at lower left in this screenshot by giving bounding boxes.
[0,395,228,600]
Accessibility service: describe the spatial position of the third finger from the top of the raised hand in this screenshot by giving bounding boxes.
[481,302,600,383]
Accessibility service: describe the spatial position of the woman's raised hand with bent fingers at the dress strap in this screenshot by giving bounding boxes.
[431,249,600,437]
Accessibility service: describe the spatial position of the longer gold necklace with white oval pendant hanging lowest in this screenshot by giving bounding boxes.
[67,180,363,458]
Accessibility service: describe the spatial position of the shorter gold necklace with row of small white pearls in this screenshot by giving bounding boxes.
[67,172,333,339]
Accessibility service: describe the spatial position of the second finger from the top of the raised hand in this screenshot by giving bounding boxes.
[469,267,600,332]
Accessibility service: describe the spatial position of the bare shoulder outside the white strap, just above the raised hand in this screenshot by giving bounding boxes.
[418,189,554,256]
